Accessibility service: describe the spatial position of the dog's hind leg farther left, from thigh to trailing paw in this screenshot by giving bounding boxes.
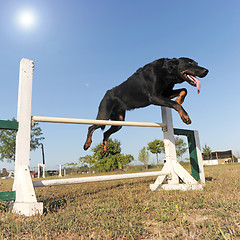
[83,91,114,150]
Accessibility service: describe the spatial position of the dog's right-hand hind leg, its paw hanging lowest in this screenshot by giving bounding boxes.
[102,110,125,155]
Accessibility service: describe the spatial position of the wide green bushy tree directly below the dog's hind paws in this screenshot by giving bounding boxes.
[79,139,134,171]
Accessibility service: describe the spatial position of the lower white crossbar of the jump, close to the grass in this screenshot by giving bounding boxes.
[33,171,170,187]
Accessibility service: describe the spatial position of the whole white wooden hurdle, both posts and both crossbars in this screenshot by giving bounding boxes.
[12,59,202,216]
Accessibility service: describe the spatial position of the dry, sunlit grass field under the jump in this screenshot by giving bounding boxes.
[0,163,240,240]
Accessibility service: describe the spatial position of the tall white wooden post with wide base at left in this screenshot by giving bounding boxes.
[11,58,43,216]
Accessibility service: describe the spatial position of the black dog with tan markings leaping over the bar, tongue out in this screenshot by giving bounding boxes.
[84,58,208,154]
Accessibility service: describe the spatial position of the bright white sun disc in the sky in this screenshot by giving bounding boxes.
[17,9,36,30]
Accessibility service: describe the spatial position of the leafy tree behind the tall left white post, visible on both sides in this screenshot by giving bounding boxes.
[0,118,44,162]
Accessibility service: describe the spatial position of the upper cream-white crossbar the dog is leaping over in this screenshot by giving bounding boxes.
[32,116,166,128]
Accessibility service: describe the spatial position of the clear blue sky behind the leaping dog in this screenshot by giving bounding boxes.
[0,0,240,169]
